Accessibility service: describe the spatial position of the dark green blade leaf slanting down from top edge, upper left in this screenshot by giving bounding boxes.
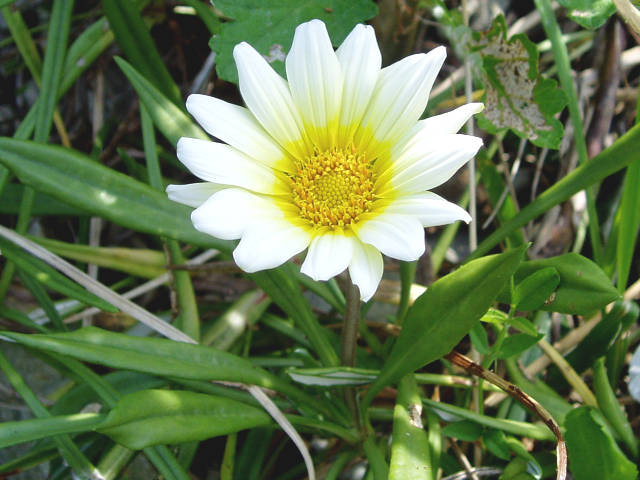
[102,0,183,107]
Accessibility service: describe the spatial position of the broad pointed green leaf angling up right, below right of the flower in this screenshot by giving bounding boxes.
[364,246,527,405]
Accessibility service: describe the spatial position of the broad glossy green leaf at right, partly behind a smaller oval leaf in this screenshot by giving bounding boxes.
[508,253,620,315]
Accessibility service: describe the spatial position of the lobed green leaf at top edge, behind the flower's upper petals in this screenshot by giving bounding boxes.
[211,0,378,83]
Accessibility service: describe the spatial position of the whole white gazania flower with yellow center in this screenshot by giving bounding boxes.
[167,20,482,300]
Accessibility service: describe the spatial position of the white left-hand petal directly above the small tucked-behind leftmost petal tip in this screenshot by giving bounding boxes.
[177,137,288,194]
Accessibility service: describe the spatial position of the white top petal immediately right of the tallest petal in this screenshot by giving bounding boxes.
[336,25,382,142]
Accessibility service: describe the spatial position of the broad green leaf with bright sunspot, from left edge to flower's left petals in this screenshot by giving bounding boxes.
[0,138,232,252]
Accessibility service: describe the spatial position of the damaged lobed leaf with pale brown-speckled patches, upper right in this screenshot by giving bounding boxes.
[471,16,567,149]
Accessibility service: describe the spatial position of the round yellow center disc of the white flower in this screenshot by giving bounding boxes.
[291,147,374,228]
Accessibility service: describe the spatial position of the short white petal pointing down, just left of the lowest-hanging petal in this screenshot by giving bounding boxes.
[300,233,354,280]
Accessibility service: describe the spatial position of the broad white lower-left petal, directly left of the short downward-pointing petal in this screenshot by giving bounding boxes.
[233,218,311,273]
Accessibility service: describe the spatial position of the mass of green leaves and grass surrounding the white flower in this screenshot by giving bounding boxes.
[0,0,640,480]
